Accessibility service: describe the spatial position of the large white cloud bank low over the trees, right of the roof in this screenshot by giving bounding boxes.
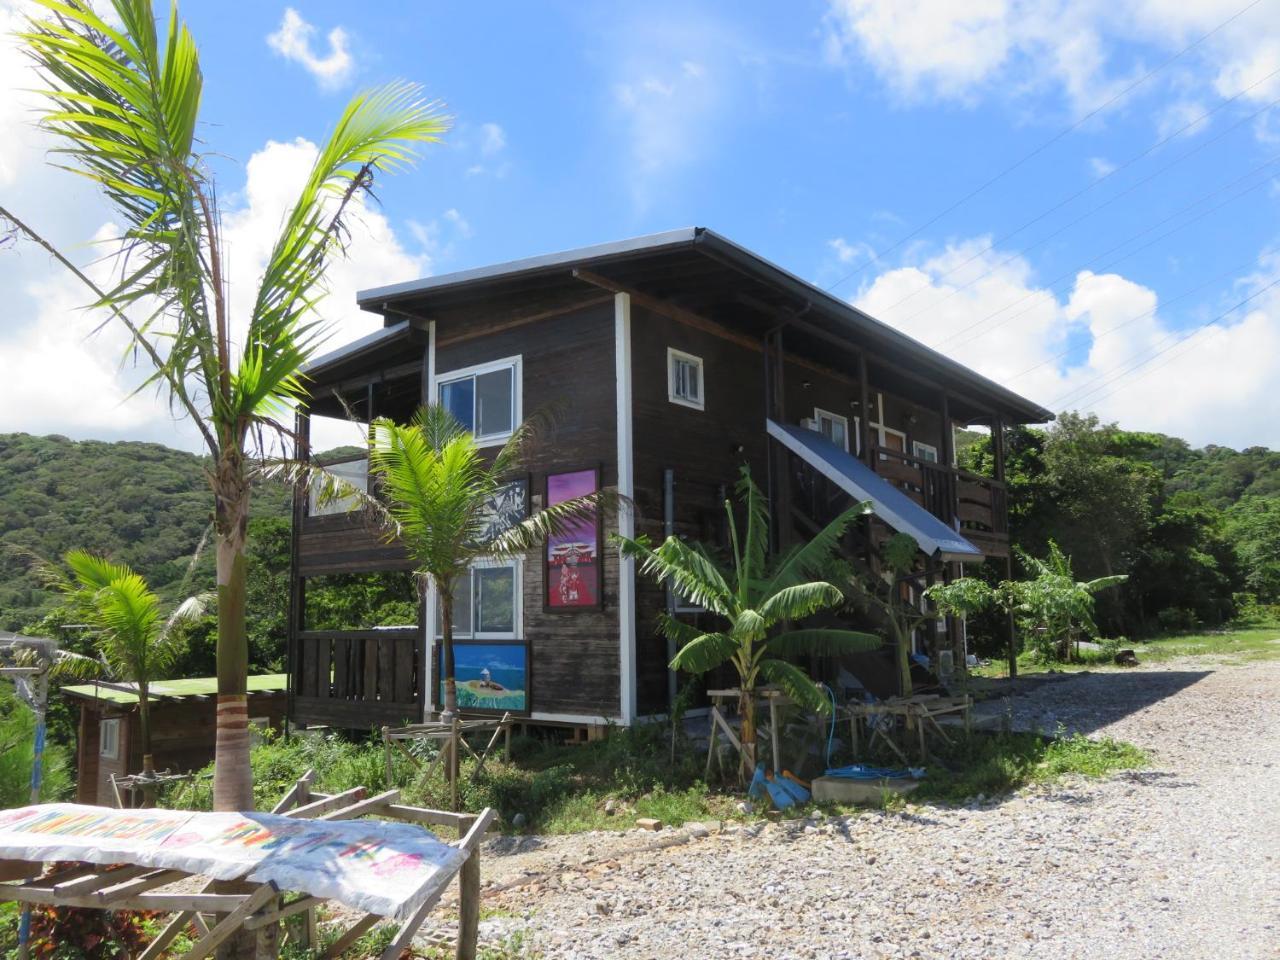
[854,237,1280,447]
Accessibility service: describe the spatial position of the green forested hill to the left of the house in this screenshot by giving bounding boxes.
[0,434,289,630]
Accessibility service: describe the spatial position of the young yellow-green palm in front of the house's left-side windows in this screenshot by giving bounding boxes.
[368,404,618,717]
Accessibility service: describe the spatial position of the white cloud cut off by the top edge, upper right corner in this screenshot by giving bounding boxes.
[826,0,1280,122]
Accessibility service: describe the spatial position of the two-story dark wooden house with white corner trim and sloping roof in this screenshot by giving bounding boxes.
[289,228,1052,728]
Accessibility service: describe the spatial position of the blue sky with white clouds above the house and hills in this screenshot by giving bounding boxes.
[0,0,1280,447]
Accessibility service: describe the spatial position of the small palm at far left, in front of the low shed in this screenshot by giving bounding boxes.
[45,550,210,788]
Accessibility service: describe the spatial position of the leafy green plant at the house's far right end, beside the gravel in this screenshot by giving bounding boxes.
[998,540,1128,662]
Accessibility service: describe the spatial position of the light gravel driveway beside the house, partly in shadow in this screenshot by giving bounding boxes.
[468,659,1280,960]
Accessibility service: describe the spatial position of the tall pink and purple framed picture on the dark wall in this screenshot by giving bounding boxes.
[543,467,602,612]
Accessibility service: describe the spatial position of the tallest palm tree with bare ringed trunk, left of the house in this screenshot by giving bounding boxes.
[0,0,447,810]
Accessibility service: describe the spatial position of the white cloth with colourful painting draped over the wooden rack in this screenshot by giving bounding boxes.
[0,804,467,920]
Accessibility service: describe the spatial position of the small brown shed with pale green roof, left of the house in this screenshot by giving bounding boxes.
[63,673,287,805]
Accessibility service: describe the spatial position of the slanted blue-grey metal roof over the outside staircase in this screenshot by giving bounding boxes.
[767,420,983,563]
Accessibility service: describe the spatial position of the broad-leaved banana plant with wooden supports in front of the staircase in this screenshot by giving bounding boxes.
[616,467,879,771]
